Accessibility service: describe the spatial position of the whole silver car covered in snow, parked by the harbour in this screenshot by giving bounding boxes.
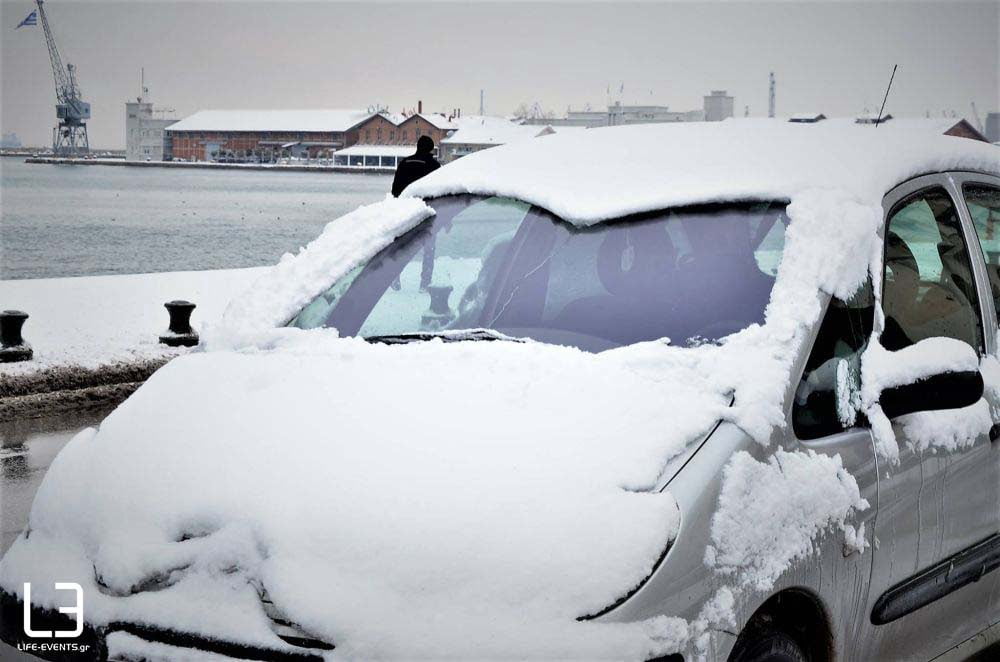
[0,126,1000,662]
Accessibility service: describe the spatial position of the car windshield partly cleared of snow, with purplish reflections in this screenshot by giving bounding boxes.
[289,195,787,351]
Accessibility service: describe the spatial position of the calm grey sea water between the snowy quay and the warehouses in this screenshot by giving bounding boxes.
[0,157,392,280]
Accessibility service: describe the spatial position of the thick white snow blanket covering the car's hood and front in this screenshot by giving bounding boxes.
[3,340,728,658]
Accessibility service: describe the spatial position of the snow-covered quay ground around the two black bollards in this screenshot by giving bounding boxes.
[0,267,267,376]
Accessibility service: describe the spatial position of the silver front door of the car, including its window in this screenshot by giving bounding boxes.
[862,175,1000,660]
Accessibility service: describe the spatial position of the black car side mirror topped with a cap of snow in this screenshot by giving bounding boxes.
[878,338,983,419]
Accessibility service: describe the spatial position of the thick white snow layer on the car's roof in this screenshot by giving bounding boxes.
[404,122,1000,225]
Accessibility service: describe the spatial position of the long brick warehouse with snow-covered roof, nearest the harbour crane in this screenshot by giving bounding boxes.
[166,110,371,161]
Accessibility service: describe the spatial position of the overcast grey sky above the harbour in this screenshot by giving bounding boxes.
[0,0,1000,148]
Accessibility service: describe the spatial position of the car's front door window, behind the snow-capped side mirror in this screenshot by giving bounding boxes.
[882,187,984,353]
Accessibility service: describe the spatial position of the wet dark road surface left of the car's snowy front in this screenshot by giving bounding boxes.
[0,407,113,554]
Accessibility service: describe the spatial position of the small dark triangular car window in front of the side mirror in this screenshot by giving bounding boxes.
[792,281,875,440]
